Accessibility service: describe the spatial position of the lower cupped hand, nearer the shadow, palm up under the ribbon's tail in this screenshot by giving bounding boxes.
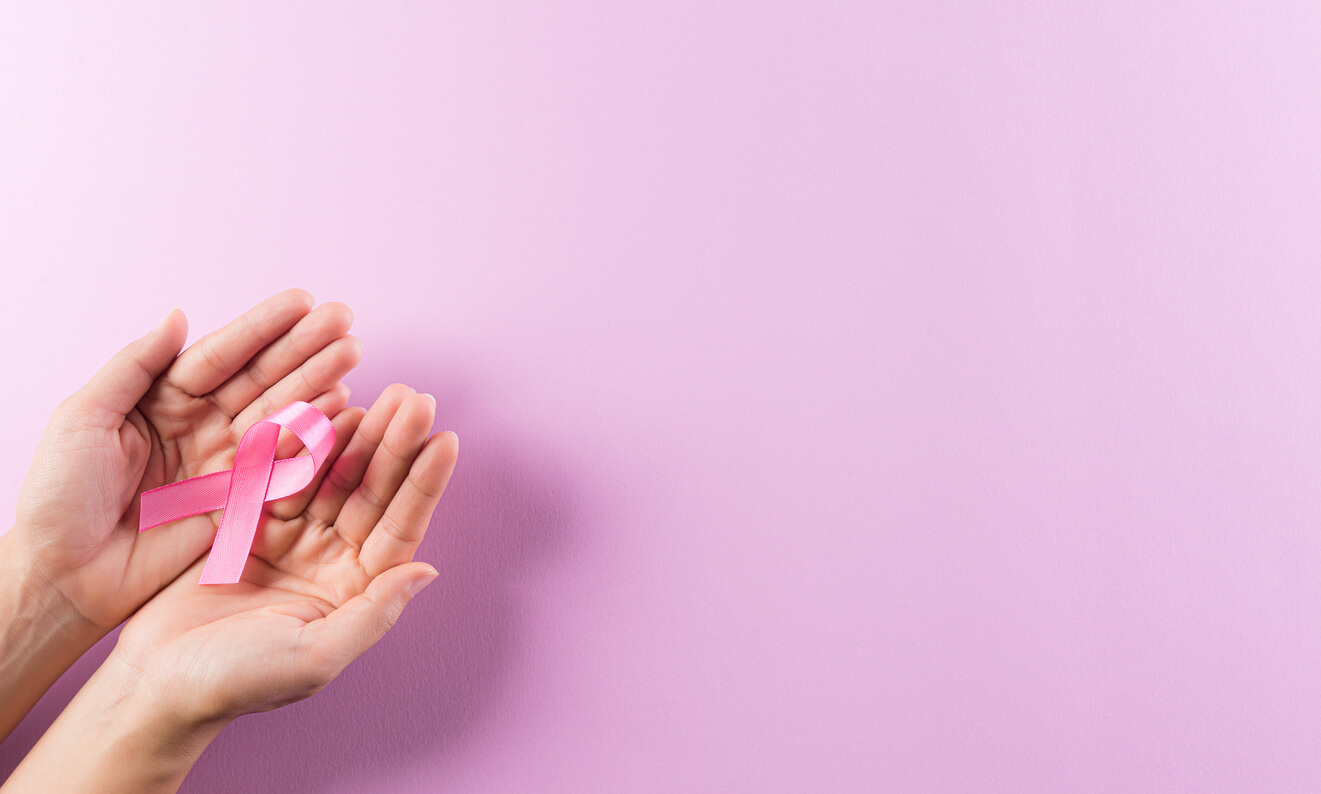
[112,384,458,721]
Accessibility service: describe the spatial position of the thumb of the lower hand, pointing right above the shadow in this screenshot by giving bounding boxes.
[300,563,437,683]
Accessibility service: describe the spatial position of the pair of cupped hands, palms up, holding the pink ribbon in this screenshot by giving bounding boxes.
[0,289,458,737]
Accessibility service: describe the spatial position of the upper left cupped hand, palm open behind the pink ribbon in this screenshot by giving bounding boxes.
[11,289,361,630]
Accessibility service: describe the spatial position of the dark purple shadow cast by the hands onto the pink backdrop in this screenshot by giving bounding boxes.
[0,343,571,794]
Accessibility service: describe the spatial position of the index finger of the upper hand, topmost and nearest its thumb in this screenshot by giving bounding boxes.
[166,289,313,396]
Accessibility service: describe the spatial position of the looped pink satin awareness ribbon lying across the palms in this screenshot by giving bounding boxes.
[137,402,334,584]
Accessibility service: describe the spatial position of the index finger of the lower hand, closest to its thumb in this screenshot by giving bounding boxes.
[358,432,458,576]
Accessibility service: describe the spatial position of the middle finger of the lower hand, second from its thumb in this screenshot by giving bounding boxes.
[334,394,436,548]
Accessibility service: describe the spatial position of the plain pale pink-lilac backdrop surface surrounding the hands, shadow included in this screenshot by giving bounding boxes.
[0,0,1321,794]
